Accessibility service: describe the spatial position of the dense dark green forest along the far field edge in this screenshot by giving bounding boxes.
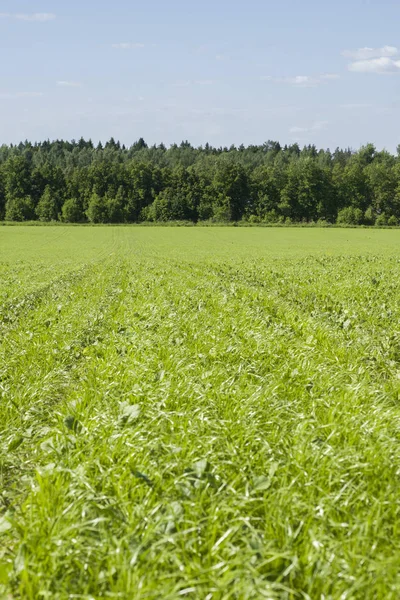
[0,138,400,226]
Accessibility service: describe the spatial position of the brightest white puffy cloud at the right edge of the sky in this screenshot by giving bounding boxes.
[342,46,400,74]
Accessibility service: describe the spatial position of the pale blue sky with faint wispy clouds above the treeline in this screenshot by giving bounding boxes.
[0,0,400,151]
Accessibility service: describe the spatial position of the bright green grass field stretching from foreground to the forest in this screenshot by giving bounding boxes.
[0,226,400,600]
